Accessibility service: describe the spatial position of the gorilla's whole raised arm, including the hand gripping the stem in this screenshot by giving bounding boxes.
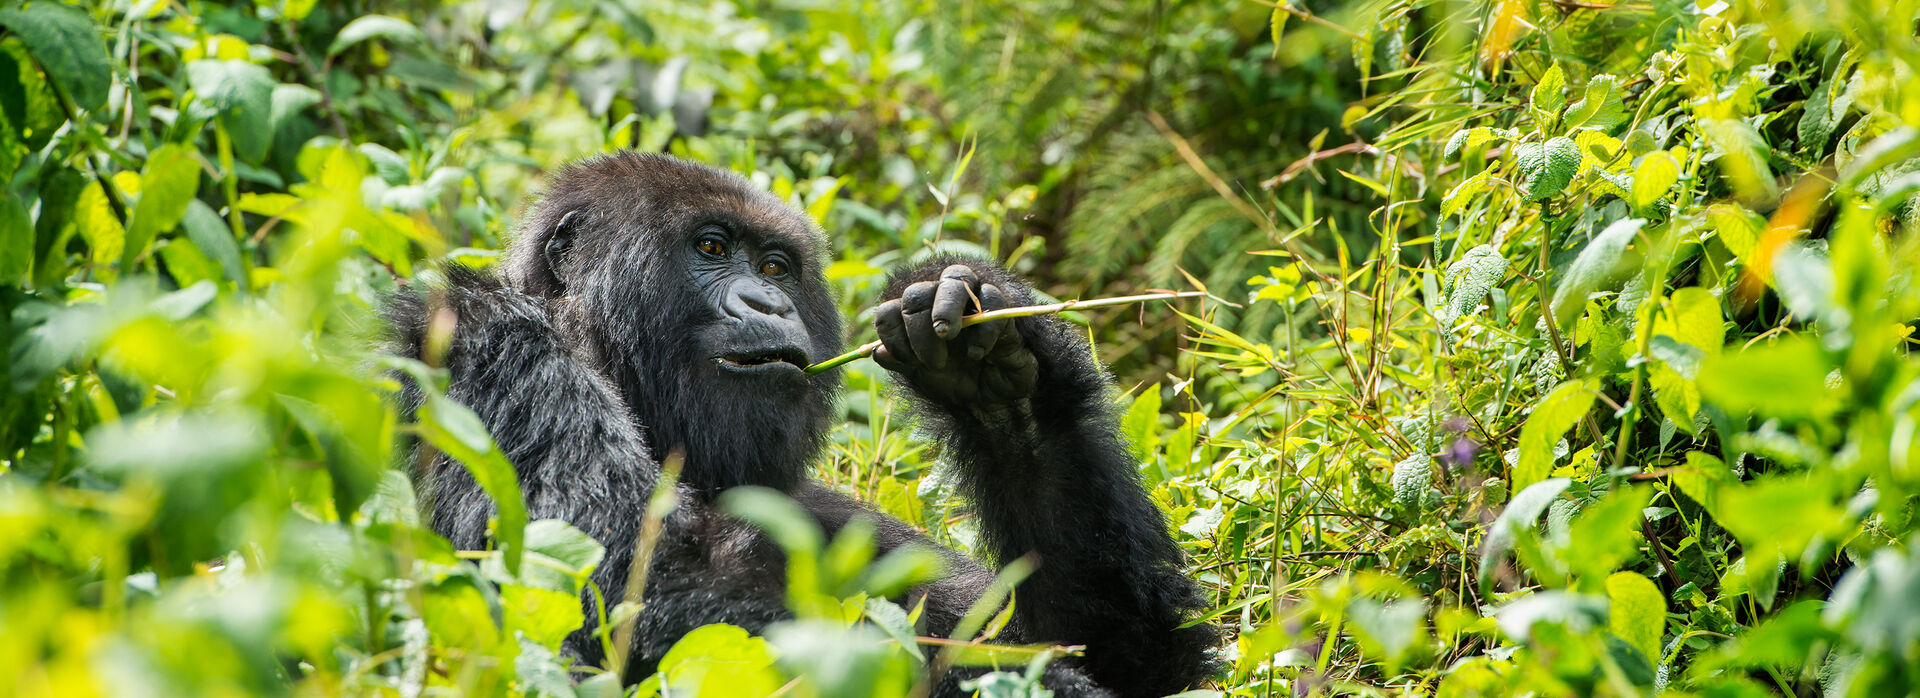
[876,259,1215,696]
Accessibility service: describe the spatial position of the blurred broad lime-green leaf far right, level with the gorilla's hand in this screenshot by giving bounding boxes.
[1699,337,1839,418]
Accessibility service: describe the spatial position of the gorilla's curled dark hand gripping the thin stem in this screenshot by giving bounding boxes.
[874,265,1039,407]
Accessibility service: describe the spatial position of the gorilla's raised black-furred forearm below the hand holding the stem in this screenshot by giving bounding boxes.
[883,259,1215,694]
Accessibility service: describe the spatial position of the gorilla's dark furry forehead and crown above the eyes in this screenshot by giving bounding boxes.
[522,151,826,255]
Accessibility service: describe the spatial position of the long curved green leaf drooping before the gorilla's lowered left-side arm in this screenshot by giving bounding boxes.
[420,393,526,575]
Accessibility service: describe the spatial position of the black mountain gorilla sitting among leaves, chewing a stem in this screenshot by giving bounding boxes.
[386,151,1215,696]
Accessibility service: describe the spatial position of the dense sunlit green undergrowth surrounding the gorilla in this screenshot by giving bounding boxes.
[0,0,1920,696]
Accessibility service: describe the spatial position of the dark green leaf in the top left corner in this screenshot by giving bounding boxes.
[0,2,113,111]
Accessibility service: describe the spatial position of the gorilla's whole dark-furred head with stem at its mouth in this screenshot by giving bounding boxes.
[509,153,841,493]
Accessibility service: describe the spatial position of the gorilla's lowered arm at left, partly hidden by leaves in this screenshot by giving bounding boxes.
[386,267,789,677]
